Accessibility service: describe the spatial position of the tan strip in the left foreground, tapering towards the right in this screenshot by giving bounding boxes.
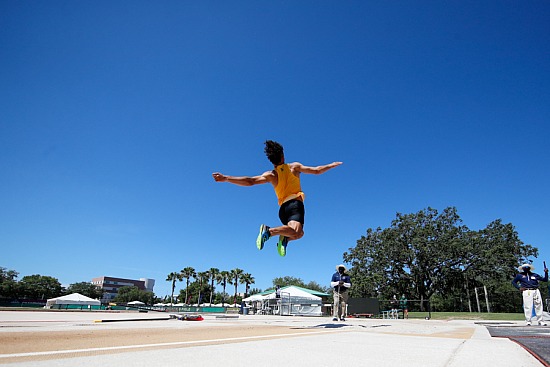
[0,320,338,364]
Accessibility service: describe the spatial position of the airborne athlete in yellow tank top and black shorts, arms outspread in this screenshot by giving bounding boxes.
[212,140,342,256]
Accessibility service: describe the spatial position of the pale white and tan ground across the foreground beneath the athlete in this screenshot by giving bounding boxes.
[0,311,541,367]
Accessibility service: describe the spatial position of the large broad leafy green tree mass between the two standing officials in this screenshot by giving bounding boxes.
[343,207,537,307]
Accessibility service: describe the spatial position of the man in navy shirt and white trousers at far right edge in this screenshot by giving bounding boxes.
[512,264,548,326]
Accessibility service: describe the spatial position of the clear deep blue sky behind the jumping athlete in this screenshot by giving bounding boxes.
[0,0,550,296]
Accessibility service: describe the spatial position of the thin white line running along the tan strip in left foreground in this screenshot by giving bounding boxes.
[0,330,341,359]
